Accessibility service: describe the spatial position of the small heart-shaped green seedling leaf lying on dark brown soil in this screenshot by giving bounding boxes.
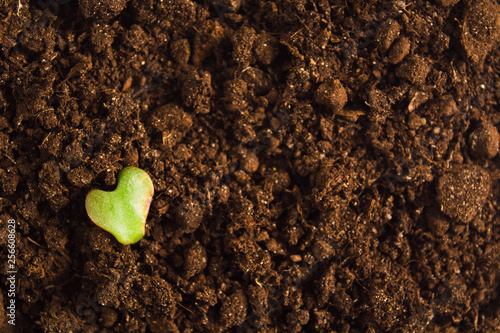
[85,167,154,245]
